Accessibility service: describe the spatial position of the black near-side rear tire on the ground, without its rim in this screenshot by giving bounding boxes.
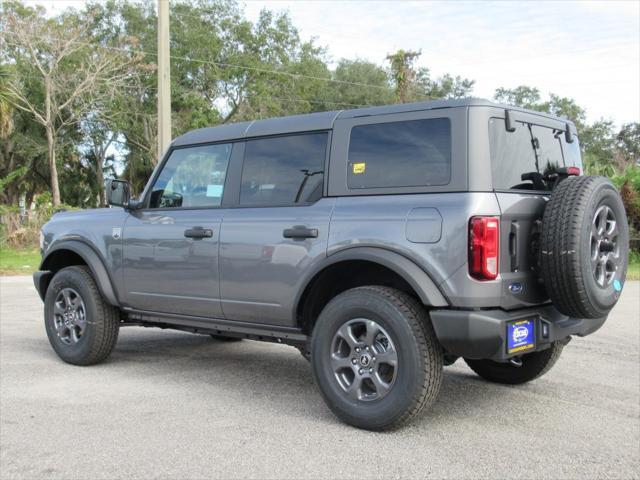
[311,286,443,430]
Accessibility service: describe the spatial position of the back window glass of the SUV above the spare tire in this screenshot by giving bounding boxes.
[489,118,564,190]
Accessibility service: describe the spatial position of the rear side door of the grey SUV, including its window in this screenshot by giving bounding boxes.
[220,132,335,326]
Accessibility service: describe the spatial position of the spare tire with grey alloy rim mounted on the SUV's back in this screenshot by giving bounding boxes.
[540,176,629,318]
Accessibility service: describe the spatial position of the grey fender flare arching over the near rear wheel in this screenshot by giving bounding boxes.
[293,247,449,318]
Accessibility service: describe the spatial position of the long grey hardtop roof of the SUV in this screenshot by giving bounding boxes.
[171,98,573,147]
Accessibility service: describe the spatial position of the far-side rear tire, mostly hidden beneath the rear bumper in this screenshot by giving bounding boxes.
[464,342,564,385]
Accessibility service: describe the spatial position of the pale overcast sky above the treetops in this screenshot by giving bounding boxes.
[29,0,640,124]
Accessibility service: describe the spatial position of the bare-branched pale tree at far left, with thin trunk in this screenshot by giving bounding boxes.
[5,3,138,207]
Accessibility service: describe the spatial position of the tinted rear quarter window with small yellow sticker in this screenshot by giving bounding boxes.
[347,118,451,189]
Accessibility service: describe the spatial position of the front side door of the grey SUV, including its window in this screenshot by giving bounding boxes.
[122,143,233,318]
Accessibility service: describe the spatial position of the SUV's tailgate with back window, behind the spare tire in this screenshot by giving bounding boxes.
[489,112,582,308]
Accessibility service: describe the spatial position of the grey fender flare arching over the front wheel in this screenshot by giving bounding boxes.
[34,240,120,307]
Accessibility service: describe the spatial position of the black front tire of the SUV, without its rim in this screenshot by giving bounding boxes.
[44,266,120,365]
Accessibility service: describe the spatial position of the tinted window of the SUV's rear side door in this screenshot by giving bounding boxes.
[240,133,328,207]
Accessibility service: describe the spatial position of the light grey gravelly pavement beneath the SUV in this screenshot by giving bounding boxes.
[0,277,640,479]
